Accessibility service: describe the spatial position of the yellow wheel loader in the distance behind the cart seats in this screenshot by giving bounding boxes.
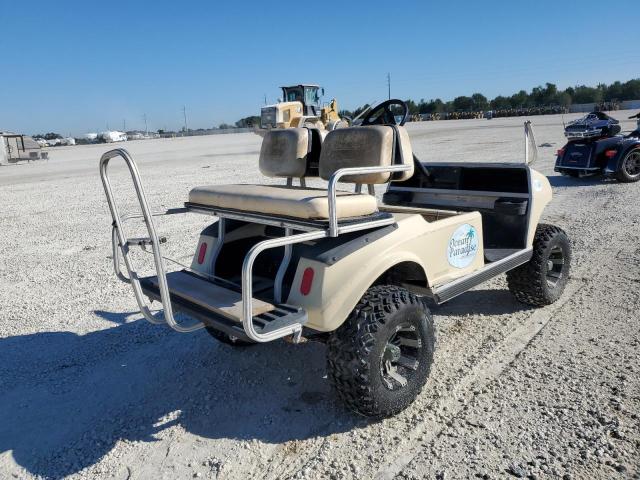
[256,84,349,136]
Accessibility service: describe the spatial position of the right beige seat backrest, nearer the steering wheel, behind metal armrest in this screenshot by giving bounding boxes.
[320,125,413,185]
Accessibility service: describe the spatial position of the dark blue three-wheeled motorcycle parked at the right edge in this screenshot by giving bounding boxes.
[555,112,640,183]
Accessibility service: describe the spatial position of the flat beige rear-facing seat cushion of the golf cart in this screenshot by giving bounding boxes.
[189,185,378,219]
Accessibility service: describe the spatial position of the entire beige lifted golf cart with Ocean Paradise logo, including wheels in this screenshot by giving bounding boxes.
[100,100,571,417]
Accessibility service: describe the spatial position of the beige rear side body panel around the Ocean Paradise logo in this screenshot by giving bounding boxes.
[287,212,484,331]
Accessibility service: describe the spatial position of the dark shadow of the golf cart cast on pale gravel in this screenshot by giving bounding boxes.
[0,312,358,478]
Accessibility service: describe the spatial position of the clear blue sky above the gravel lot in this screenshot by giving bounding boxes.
[0,0,640,135]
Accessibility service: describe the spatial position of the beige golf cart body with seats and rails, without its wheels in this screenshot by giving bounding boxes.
[101,125,552,342]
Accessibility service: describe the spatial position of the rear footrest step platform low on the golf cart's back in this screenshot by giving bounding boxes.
[140,270,308,340]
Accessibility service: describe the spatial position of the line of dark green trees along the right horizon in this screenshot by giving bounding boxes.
[340,78,640,118]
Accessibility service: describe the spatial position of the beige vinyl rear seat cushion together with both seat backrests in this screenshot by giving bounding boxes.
[189,126,413,220]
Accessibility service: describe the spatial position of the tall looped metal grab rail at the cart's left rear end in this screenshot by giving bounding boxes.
[100,148,204,333]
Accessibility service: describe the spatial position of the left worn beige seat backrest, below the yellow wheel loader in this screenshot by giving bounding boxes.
[259,128,323,178]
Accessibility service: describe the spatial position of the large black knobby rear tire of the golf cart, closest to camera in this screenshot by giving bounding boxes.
[327,285,435,418]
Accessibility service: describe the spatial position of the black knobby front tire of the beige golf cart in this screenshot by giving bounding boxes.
[507,223,571,306]
